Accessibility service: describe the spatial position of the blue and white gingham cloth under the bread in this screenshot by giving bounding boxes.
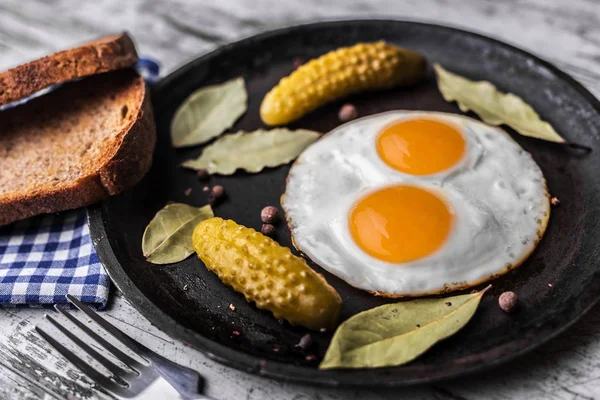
[0,58,159,309]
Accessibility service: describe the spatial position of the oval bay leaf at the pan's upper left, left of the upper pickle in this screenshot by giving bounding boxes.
[171,77,248,147]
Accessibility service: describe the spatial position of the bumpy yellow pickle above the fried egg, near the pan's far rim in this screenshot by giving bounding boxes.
[260,41,426,126]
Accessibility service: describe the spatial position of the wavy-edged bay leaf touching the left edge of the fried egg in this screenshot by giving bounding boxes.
[182,128,320,175]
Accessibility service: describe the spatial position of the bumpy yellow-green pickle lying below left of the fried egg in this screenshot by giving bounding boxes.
[192,217,342,331]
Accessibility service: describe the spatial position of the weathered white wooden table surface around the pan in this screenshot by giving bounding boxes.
[0,0,600,400]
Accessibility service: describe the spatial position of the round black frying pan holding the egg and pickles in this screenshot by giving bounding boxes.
[89,20,600,387]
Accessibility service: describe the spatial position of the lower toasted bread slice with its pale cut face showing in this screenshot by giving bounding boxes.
[0,69,156,225]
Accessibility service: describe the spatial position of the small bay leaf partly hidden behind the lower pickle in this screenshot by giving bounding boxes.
[142,203,214,264]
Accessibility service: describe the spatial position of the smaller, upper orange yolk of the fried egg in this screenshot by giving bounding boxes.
[377,118,466,175]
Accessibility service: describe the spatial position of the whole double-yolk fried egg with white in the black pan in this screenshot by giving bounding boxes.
[282,111,550,297]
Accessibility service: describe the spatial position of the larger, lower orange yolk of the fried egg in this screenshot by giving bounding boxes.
[348,185,454,263]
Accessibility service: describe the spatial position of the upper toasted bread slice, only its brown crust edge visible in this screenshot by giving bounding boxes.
[0,33,138,106]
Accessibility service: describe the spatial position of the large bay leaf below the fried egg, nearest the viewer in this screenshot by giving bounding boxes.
[319,286,489,369]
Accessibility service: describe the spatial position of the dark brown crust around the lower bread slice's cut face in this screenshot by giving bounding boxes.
[0,71,156,225]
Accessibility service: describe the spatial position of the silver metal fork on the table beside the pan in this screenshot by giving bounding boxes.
[35,294,210,400]
